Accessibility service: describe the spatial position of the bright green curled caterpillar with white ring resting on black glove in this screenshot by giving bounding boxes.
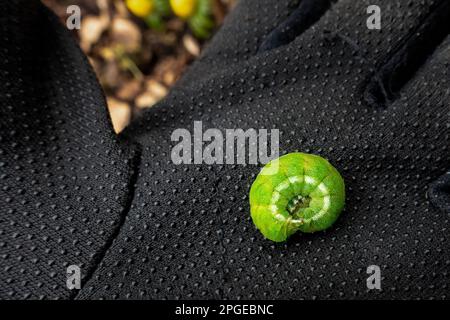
[250,153,345,242]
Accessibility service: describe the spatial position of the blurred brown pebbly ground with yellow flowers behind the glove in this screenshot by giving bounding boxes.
[43,0,237,132]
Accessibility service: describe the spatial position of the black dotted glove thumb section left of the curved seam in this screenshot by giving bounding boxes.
[0,0,138,299]
